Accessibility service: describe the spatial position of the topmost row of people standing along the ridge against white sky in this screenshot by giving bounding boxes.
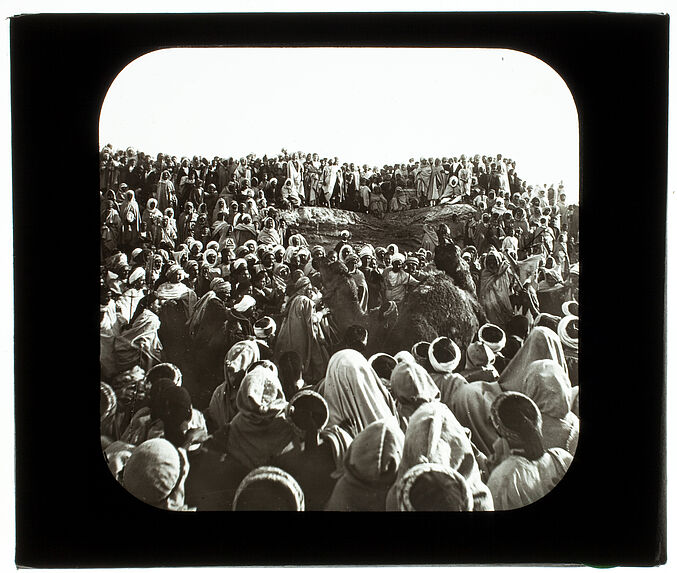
[99,145,575,218]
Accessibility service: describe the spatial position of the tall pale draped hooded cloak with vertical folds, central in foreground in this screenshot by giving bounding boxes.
[318,348,397,432]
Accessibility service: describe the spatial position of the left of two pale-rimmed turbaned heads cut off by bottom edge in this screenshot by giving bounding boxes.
[233,466,305,511]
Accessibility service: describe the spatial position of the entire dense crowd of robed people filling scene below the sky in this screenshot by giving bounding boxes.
[100,146,579,511]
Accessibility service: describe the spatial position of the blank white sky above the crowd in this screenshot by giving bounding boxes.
[99,48,579,199]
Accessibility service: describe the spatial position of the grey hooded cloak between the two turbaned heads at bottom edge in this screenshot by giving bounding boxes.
[326,418,404,511]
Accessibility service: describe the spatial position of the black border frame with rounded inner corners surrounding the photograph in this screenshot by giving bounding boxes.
[10,12,669,567]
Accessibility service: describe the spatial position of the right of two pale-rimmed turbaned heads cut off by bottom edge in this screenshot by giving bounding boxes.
[395,462,473,511]
